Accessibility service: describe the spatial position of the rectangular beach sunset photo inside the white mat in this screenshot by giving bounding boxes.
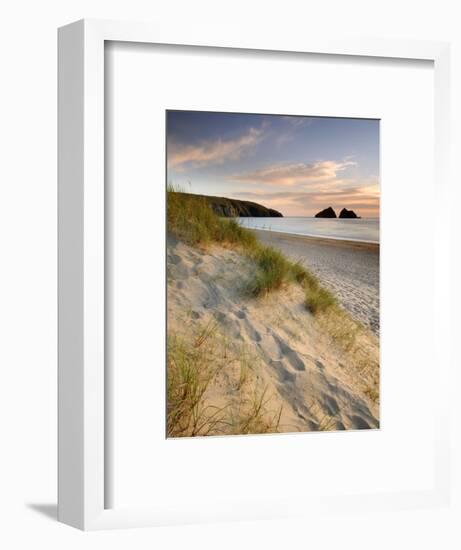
[165,110,380,438]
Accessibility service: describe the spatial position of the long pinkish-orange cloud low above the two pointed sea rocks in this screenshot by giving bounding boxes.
[232,160,357,186]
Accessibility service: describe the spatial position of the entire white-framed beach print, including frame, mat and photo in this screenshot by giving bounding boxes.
[59,20,451,529]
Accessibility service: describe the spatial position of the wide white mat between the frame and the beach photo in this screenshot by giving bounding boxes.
[106,44,436,518]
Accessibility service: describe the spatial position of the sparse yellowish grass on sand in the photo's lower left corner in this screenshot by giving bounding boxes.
[167,324,282,437]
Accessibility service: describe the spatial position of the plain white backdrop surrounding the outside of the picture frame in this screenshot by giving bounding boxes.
[0,0,461,549]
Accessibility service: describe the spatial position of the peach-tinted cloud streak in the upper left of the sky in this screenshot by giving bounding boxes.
[168,128,264,171]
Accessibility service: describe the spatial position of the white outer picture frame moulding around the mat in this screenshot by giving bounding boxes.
[58,20,451,530]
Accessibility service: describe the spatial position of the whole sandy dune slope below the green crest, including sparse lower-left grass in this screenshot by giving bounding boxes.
[167,236,379,436]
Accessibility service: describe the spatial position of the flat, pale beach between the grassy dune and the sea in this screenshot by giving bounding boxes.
[252,230,379,335]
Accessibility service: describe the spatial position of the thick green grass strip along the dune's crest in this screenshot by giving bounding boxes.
[167,186,336,315]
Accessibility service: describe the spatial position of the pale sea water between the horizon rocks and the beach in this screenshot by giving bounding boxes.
[237,217,379,243]
